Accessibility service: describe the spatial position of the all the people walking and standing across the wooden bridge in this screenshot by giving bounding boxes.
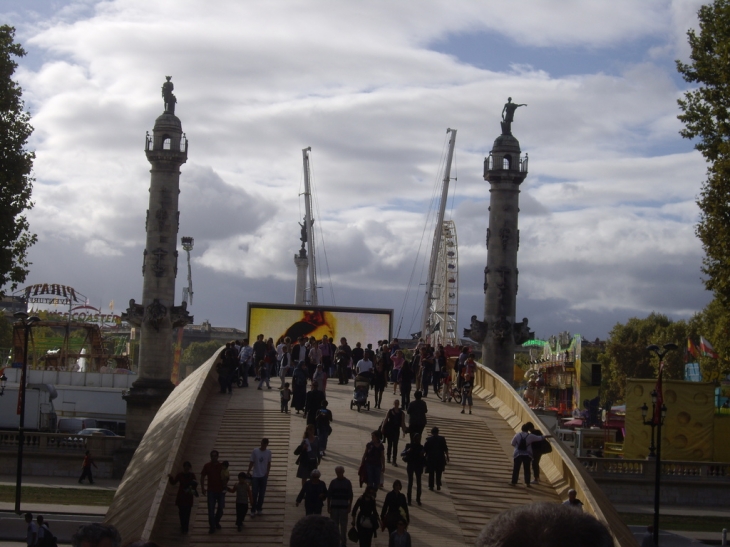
[152,335,616,547]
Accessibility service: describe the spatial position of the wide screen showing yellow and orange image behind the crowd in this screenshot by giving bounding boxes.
[246,302,393,347]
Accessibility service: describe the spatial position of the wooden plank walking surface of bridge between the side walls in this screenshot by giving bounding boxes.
[150,380,564,547]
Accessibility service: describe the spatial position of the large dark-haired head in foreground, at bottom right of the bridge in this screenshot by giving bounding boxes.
[474,502,613,547]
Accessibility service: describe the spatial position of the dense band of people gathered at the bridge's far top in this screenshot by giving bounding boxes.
[218,334,484,414]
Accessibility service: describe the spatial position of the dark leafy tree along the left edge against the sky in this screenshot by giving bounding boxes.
[0,25,37,294]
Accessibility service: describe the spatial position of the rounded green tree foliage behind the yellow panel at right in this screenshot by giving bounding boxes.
[598,313,688,402]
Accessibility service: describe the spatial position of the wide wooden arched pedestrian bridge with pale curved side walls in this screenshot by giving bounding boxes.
[106,351,636,547]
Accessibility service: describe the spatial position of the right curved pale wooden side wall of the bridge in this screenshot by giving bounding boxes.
[474,364,638,547]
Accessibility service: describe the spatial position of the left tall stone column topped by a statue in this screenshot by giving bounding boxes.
[122,77,193,452]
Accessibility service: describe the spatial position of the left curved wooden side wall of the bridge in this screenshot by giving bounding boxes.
[106,347,223,545]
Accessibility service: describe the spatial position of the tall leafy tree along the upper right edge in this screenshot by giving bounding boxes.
[677,0,730,305]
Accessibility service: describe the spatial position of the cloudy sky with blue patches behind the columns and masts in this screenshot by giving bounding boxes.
[0,0,711,342]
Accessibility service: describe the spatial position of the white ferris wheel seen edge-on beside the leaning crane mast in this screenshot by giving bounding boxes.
[428,220,460,347]
